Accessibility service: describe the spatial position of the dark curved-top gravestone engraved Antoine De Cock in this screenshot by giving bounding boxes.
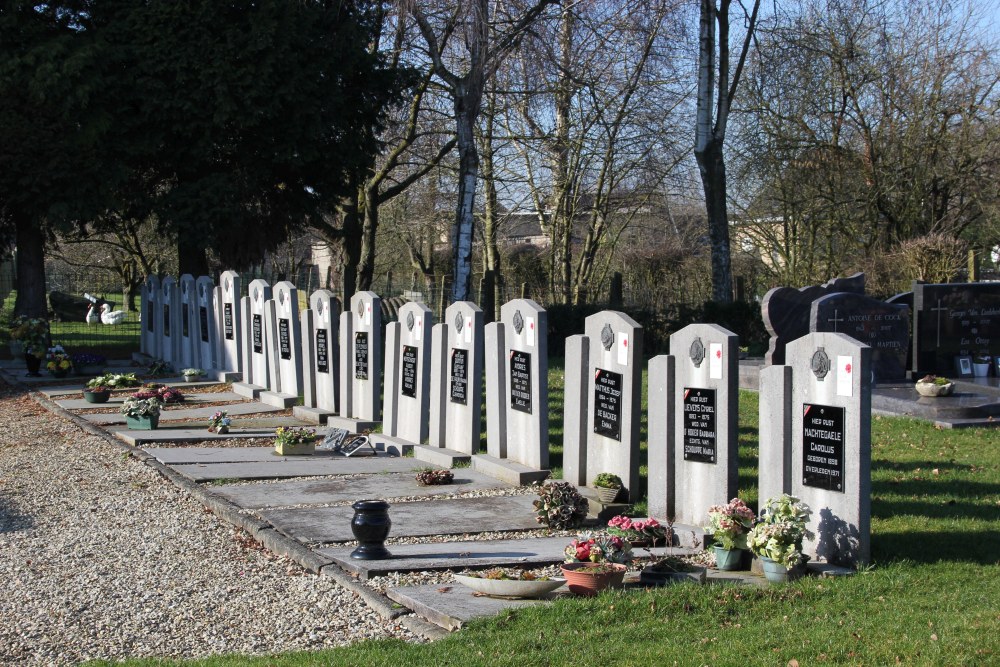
[809,292,910,382]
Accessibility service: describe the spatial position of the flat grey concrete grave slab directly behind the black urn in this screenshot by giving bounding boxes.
[258,494,538,542]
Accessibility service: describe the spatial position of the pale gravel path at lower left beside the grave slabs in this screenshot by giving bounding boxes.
[0,382,415,665]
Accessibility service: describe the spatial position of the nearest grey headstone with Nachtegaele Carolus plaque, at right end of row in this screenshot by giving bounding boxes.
[759,333,872,567]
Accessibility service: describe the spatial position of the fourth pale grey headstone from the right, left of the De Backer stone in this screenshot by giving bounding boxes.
[472,299,549,484]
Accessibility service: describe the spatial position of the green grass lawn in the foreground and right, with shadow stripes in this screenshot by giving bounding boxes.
[90,378,1000,667]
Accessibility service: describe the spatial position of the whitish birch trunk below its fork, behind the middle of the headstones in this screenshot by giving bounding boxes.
[451,94,479,301]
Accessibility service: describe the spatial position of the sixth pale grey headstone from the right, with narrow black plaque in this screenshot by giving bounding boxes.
[382,301,433,445]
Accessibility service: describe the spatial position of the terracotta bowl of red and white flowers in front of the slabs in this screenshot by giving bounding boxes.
[561,533,632,596]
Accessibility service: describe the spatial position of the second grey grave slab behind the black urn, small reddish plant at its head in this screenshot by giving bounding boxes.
[213,468,507,509]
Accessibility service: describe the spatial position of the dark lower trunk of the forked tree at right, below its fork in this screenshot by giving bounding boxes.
[695,140,733,303]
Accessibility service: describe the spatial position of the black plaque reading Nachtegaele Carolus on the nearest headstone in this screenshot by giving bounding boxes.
[802,403,844,493]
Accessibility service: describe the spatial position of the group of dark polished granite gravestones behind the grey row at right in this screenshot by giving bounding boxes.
[761,273,1000,382]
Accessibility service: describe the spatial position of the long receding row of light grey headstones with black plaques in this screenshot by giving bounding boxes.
[143,272,871,564]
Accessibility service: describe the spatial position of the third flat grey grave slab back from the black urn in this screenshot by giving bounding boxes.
[171,454,421,482]
